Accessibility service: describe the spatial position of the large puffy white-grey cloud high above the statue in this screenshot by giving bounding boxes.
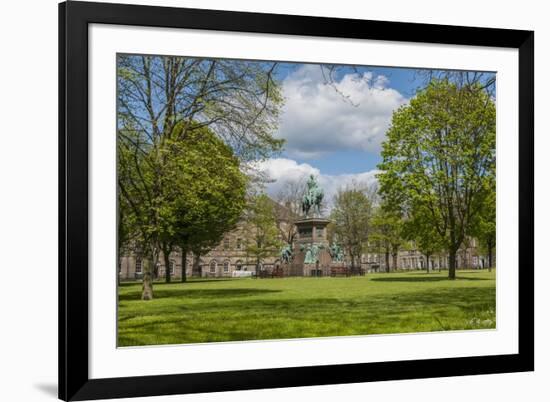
[277,65,407,158]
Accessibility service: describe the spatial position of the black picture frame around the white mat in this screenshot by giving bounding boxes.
[59,1,534,400]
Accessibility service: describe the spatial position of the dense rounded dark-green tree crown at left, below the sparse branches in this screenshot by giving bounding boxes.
[118,123,247,296]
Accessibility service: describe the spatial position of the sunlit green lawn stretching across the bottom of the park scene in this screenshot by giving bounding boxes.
[118,271,496,346]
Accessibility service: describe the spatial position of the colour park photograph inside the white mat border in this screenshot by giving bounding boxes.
[113,53,497,347]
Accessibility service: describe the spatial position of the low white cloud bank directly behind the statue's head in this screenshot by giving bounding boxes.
[256,158,379,209]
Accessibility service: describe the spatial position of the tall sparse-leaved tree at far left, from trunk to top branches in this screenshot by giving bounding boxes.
[117,55,283,298]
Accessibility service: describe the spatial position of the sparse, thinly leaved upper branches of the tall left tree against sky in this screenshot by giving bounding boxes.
[117,55,284,161]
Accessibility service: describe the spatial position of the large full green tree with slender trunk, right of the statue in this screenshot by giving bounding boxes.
[378,80,496,279]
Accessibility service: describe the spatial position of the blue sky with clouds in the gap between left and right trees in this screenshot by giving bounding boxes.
[259,63,496,205]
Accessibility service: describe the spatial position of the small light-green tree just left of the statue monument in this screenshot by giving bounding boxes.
[245,194,282,275]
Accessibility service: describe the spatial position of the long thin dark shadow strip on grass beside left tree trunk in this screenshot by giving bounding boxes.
[118,286,281,301]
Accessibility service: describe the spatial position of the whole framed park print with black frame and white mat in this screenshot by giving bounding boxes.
[59,1,534,400]
